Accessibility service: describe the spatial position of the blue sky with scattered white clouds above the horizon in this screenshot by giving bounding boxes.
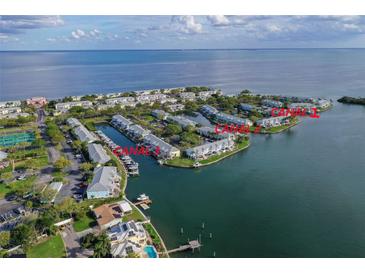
[0,15,365,50]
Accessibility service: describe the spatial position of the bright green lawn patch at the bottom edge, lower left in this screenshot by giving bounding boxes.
[27,235,66,258]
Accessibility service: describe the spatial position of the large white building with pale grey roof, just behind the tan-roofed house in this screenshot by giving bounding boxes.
[86,166,121,199]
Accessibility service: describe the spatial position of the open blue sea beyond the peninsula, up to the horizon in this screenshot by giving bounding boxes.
[0,49,365,100]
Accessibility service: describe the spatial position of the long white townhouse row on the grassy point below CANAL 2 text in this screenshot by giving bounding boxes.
[185,138,235,160]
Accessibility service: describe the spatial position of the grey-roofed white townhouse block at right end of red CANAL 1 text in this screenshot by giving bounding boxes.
[143,134,180,159]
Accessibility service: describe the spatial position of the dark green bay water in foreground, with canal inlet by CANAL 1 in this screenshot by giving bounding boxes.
[98,104,365,257]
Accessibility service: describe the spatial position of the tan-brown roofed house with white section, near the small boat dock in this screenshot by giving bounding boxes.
[93,200,132,230]
